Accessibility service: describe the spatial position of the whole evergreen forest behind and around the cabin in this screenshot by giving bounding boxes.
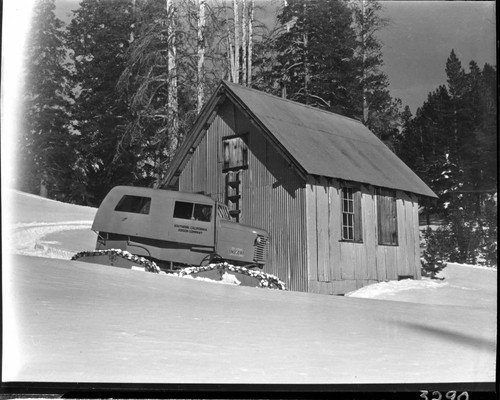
[17,0,497,264]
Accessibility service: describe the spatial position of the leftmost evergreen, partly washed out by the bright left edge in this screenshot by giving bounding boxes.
[19,0,74,199]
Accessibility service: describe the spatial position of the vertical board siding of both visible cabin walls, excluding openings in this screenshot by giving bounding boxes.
[179,102,420,294]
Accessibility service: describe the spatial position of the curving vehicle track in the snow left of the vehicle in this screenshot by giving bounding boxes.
[5,221,92,259]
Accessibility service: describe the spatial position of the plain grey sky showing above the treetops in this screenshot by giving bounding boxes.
[52,0,496,113]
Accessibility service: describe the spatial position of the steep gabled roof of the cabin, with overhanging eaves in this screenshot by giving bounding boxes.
[166,82,437,197]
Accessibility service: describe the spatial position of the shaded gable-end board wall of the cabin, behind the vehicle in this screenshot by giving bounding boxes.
[179,102,308,291]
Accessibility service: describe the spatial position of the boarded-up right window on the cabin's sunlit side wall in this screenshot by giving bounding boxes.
[377,188,398,246]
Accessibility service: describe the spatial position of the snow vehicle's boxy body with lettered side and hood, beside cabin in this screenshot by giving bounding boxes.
[75,186,269,271]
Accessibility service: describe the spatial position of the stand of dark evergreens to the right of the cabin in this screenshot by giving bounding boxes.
[397,51,497,268]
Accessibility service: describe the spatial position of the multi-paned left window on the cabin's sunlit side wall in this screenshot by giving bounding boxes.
[342,186,363,242]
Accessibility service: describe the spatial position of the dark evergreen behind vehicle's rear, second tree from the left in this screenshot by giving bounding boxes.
[68,0,140,205]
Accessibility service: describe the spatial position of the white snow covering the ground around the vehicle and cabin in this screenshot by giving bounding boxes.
[2,192,497,384]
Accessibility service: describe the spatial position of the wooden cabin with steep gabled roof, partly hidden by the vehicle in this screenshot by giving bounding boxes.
[164,82,436,294]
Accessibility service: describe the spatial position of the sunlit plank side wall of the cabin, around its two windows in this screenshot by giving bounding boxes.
[306,177,420,294]
